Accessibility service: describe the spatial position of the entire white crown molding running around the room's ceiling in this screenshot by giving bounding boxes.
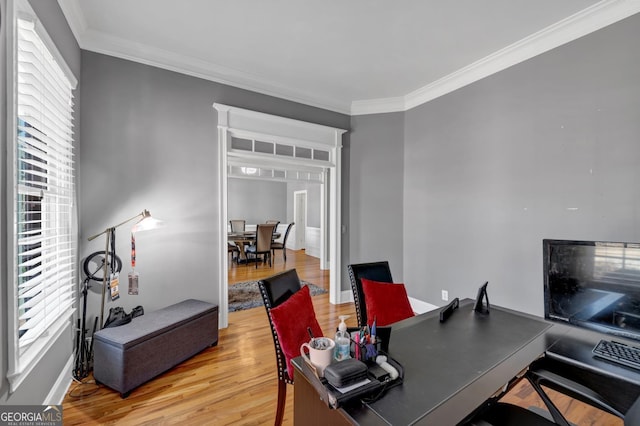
[58,0,640,115]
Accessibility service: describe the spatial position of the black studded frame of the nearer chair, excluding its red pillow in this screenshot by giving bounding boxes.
[258,269,302,425]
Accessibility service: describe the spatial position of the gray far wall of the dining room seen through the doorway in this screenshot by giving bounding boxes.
[227,178,287,225]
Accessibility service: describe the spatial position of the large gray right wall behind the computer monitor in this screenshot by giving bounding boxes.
[402,15,640,315]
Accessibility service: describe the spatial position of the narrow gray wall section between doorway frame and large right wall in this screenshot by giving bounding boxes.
[343,113,404,287]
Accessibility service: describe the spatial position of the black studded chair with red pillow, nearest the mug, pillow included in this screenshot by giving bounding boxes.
[258,269,322,426]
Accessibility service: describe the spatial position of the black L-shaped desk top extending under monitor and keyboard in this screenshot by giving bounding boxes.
[294,300,640,425]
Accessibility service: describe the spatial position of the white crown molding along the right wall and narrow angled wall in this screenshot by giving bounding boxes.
[351,0,640,115]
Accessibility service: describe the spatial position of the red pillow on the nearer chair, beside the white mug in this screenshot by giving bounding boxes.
[270,285,323,379]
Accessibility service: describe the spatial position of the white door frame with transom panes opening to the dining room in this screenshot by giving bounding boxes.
[213,103,349,328]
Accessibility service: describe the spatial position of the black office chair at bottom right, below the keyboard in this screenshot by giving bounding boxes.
[463,358,640,426]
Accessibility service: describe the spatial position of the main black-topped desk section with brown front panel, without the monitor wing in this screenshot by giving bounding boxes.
[293,300,562,425]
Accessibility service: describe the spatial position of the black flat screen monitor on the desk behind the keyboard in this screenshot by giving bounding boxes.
[543,239,640,340]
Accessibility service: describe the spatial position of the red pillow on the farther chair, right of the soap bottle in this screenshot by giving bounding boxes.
[361,278,414,326]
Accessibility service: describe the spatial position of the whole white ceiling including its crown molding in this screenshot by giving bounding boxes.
[58,0,640,115]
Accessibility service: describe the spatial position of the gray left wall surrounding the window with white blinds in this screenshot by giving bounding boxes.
[0,0,81,405]
